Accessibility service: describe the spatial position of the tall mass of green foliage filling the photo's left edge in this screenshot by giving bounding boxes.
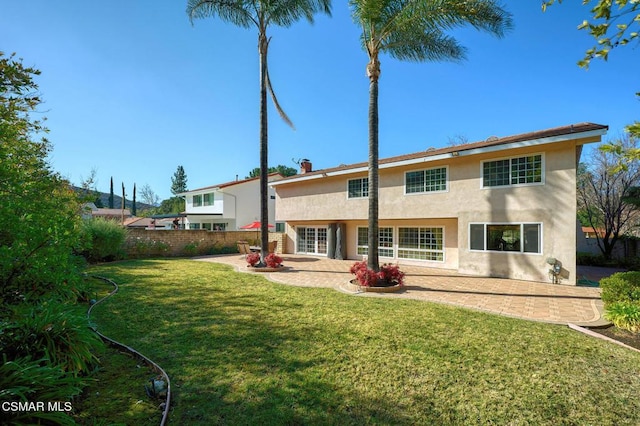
[0,51,99,424]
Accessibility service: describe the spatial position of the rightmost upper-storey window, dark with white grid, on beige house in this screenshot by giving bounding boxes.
[482,154,543,188]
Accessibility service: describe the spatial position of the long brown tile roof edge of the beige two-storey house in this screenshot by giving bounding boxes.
[279,123,609,183]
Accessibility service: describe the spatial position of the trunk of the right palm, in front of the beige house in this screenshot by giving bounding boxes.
[367,55,380,272]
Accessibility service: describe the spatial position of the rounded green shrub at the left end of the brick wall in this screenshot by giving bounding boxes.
[80,218,127,262]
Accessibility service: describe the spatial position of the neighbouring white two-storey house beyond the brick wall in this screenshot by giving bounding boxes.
[178,173,282,231]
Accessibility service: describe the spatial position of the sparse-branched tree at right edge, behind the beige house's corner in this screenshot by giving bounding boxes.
[577,136,640,259]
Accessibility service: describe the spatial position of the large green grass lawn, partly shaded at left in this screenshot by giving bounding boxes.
[86,260,640,425]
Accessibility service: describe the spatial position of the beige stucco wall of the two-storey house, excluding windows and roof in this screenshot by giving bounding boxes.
[276,141,592,285]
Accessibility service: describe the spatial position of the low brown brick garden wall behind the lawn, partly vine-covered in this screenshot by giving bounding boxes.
[125,228,285,257]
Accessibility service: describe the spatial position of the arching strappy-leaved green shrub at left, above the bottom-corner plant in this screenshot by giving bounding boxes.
[0,301,102,375]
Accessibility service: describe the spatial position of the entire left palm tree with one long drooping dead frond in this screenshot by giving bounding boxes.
[187,0,331,264]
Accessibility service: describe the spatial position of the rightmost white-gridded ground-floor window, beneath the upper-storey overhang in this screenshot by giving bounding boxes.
[398,227,444,262]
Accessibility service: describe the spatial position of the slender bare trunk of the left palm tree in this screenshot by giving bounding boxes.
[258,30,269,265]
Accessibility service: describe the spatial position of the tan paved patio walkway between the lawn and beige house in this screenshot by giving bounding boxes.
[197,254,607,326]
